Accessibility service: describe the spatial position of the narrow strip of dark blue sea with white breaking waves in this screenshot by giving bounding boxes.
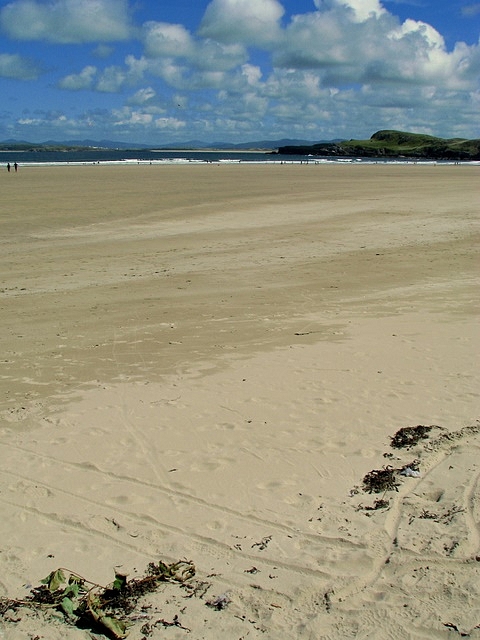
[0,149,472,166]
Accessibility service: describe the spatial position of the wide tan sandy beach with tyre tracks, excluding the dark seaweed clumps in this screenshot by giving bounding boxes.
[0,164,480,640]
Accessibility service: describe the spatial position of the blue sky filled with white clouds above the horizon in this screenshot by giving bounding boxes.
[0,0,480,145]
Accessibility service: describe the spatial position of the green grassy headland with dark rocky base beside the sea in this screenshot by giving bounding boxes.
[278,130,480,160]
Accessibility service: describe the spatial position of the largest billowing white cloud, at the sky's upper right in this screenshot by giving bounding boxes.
[273,0,479,89]
